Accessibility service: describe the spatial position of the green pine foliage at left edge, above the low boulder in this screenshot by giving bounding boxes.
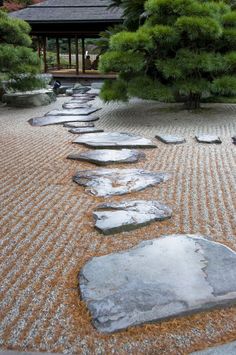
[0,11,41,90]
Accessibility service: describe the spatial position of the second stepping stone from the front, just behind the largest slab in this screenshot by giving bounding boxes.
[93,201,172,235]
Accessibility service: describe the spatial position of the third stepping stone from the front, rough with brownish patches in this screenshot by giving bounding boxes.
[73,169,170,197]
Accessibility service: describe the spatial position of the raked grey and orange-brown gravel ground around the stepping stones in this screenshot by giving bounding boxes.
[0,98,236,355]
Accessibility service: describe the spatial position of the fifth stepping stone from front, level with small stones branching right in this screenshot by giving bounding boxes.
[73,132,156,149]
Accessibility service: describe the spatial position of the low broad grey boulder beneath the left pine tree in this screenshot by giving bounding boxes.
[3,90,56,108]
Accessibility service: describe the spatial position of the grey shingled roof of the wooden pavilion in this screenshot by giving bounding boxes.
[11,0,122,24]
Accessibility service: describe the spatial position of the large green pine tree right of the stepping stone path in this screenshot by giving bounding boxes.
[99,0,236,109]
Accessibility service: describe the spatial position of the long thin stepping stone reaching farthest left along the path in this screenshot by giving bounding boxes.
[28,116,99,126]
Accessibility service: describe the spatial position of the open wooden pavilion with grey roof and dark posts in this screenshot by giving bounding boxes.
[11,0,122,76]
